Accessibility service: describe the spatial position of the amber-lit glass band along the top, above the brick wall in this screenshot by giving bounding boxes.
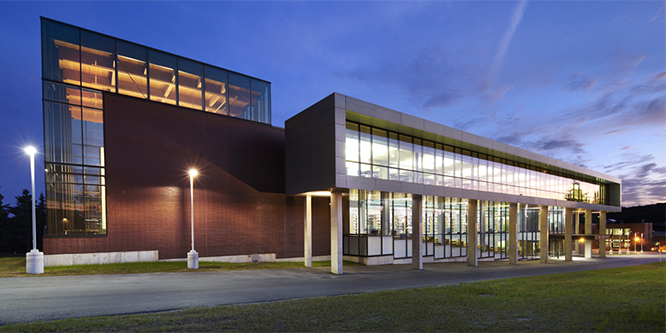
[42,19,271,124]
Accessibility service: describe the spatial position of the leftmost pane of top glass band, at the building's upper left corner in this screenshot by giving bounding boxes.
[42,20,81,86]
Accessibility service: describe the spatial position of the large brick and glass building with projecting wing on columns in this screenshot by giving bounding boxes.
[42,18,621,273]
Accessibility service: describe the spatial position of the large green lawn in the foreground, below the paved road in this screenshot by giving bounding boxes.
[0,263,666,332]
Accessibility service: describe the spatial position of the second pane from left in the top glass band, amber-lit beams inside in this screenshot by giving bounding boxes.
[81,31,116,92]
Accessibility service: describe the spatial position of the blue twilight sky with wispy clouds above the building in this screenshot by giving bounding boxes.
[0,1,666,207]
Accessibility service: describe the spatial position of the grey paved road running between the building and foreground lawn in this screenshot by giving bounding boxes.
[0,254,659,325]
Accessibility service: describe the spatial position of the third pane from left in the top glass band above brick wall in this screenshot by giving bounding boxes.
[116,41,148,99]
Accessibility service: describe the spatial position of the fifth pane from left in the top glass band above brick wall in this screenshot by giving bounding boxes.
[178,58,203,110]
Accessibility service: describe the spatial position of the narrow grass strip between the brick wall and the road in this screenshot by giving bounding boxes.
[0,257,360,277]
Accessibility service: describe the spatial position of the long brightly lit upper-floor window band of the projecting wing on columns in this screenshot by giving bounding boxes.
[345,121,608,204]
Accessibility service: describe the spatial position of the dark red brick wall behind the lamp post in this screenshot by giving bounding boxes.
[44,94,330,259]
